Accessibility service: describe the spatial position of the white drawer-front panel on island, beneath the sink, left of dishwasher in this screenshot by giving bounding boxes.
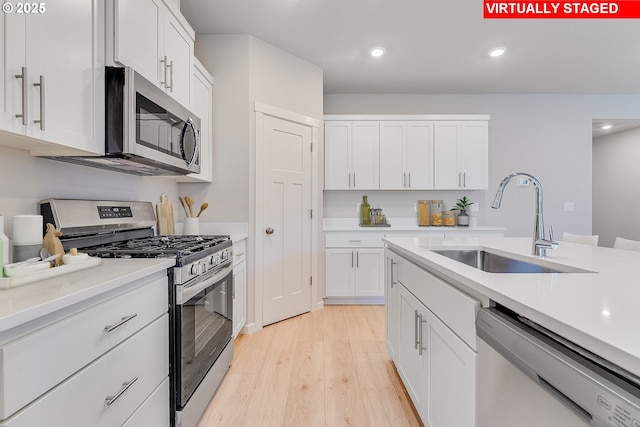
[398,258,480,350]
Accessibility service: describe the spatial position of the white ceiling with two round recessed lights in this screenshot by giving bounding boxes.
[181,0,640,94]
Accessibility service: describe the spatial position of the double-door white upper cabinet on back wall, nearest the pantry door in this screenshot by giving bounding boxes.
[325,121,380,190]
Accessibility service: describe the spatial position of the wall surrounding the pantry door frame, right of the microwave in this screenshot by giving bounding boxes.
[188,34,323,330]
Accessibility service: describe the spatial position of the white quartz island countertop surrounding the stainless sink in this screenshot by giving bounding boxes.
[383,237,640,376]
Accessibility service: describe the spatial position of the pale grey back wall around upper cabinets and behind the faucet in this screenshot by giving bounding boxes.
[324,94,640,238]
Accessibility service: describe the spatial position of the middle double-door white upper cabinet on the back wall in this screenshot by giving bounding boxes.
[380,121,433,190]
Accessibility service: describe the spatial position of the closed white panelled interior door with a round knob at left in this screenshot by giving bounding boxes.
[258,116,311,325]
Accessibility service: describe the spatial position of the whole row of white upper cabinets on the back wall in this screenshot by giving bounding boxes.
[325,115,489,190]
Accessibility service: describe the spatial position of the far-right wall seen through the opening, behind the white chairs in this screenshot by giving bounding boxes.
[593,128,640,247]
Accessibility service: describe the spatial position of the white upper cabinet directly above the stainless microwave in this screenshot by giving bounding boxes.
[107,0,195,106]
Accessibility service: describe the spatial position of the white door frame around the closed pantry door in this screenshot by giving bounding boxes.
[250,101,323,332]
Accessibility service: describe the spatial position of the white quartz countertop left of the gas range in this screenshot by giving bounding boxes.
[0,258,175,332]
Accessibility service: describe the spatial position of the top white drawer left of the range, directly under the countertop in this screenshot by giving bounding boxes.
[0,277,168,419]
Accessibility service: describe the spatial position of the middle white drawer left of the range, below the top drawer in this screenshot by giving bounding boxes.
[0,314,169,427]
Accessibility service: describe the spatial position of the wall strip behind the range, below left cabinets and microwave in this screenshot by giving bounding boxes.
[0,145,178,238]
